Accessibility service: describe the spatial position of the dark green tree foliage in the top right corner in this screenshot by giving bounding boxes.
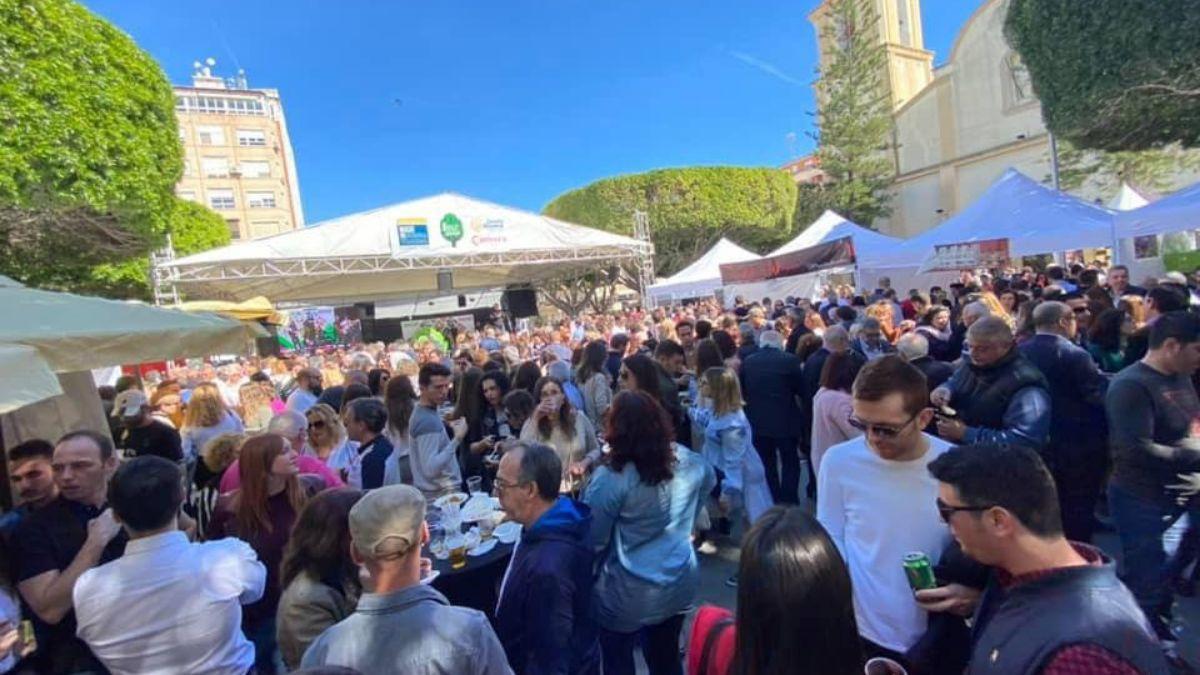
[1004,0,1200,151]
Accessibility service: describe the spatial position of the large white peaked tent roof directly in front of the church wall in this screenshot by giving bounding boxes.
[880,168,1112,267]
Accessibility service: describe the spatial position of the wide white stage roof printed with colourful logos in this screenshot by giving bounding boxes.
[162,192,653,304]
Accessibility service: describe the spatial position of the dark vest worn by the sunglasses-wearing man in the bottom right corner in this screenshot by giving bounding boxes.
[967,551,1169,675]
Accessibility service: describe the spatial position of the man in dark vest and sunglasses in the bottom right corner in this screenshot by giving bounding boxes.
[917,446,1169,675]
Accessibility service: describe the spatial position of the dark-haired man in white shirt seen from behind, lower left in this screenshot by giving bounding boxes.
[73,456,266,675]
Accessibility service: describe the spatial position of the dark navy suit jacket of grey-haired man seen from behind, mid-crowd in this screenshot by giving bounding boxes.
[739,347,804,438]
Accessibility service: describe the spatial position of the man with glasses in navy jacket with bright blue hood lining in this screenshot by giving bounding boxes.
[494,443,600,675]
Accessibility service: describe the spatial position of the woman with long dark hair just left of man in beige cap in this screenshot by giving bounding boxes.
[276,488,362,669]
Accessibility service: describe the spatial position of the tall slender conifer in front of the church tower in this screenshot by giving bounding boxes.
[812,0,895,227]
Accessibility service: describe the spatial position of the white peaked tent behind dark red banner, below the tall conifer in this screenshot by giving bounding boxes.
[725,210,916,303]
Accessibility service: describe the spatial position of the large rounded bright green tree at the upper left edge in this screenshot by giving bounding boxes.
[0,0,182,291]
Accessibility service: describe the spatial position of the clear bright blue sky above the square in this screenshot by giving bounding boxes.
[84,0,979,223]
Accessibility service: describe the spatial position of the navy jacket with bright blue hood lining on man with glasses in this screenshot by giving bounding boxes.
[496,497,600,675]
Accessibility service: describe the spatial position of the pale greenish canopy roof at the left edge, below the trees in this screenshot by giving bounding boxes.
[0,271,256,412]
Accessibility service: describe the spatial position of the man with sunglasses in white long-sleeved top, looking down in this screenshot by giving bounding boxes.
[817,354,977,661]
